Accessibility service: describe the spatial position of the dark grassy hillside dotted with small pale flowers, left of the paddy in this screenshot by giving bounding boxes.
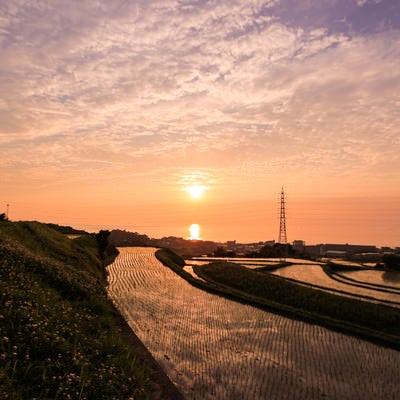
[0,221,154,399]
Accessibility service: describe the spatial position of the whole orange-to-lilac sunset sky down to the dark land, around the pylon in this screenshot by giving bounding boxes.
[0,0,400,246]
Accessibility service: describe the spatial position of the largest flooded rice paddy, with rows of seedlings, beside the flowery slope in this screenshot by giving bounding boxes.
[109,248,400,400]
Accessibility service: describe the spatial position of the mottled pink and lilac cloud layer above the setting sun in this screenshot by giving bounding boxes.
[0,0,400,197]
